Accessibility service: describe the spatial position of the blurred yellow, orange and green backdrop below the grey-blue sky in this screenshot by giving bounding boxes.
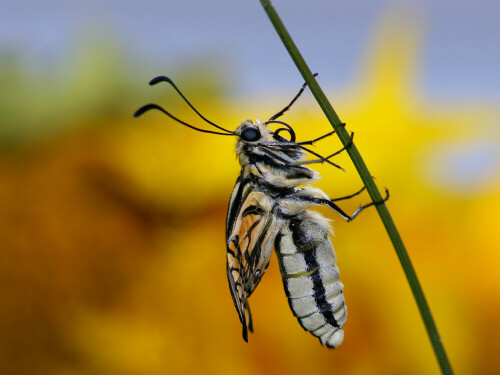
[0,2,500,375]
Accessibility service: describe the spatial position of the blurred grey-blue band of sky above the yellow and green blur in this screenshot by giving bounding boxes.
[0,0,500,100]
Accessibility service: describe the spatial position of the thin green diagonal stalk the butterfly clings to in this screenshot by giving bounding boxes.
[260,0,453,374]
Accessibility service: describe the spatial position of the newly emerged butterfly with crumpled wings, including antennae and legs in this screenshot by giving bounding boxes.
[135,76,389,348]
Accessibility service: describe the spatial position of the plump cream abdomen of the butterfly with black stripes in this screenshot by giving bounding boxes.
[275,211,347,348]
